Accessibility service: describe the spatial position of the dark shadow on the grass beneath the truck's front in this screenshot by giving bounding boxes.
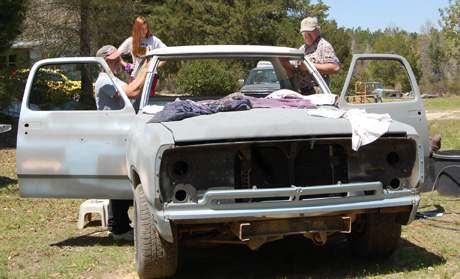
[174,236,444,279]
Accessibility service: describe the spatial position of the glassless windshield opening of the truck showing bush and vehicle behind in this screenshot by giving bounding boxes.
[147,57,328,105]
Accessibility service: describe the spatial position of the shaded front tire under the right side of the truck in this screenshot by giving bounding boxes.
[347,213,402,259]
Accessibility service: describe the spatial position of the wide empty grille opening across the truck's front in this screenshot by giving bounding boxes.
[159,137,417,203]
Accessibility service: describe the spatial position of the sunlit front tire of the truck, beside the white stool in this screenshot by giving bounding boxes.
[134,184,178,279]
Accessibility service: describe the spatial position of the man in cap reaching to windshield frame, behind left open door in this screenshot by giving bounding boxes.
[95,45,150,241]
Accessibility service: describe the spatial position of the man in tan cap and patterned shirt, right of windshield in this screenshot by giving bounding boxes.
[281,17,340,95]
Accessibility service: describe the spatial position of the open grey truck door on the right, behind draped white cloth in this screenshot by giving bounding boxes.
[339,54,430,158]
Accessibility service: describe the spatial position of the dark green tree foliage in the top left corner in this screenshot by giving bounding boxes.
[0,0,28,53]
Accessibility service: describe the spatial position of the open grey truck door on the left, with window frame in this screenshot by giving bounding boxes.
[17,58,135,199]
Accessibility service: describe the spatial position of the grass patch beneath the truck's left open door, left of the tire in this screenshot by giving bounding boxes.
[0,149,135,278]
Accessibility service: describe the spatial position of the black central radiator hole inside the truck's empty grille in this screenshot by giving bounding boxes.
[234,143,348,189]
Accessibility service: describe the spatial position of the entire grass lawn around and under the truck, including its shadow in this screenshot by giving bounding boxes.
[0,97,460,279]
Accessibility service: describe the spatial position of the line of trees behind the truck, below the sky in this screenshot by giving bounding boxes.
[0,0,460,94]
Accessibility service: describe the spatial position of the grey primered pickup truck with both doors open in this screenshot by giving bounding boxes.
[17,45,429,278]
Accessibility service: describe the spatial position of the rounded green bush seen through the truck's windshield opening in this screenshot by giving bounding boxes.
[177,60,238,95]
